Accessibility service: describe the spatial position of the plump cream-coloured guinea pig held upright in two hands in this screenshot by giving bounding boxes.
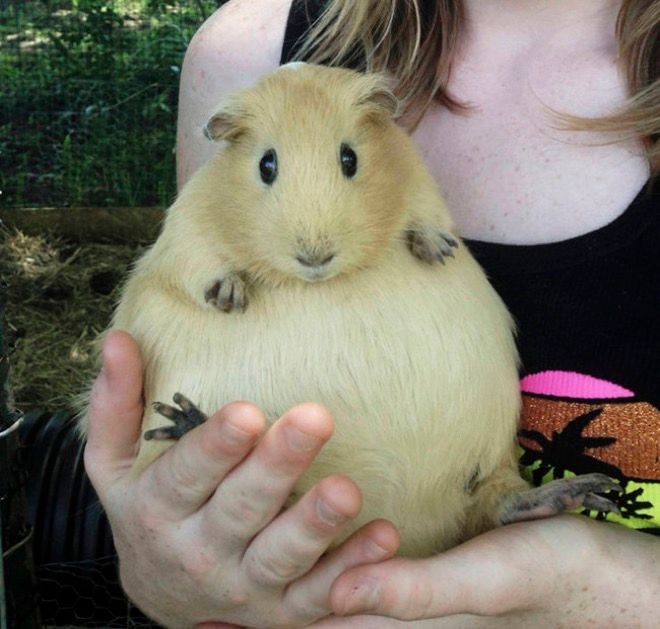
[81,64,614,556]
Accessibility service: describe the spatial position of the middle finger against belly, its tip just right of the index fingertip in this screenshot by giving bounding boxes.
[205,404,332,552]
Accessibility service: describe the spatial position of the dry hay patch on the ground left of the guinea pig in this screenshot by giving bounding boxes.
[0,229,141,411]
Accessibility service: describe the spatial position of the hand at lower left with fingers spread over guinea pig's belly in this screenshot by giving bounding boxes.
[85,332,398,628]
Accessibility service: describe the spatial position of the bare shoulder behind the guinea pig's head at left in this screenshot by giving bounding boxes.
[177,0,292,187]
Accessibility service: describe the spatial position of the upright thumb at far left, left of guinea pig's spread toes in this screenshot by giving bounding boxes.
[85,331,143,500]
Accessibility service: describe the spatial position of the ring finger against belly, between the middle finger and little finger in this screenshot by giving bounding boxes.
[241,476,362,592]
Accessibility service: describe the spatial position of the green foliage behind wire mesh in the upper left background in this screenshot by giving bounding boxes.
[0,0,224,207]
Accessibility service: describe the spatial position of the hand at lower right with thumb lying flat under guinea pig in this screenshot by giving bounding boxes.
[324,516,660,629]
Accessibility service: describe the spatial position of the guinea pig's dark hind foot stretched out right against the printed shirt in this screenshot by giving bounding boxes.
[498,474,623,524]
